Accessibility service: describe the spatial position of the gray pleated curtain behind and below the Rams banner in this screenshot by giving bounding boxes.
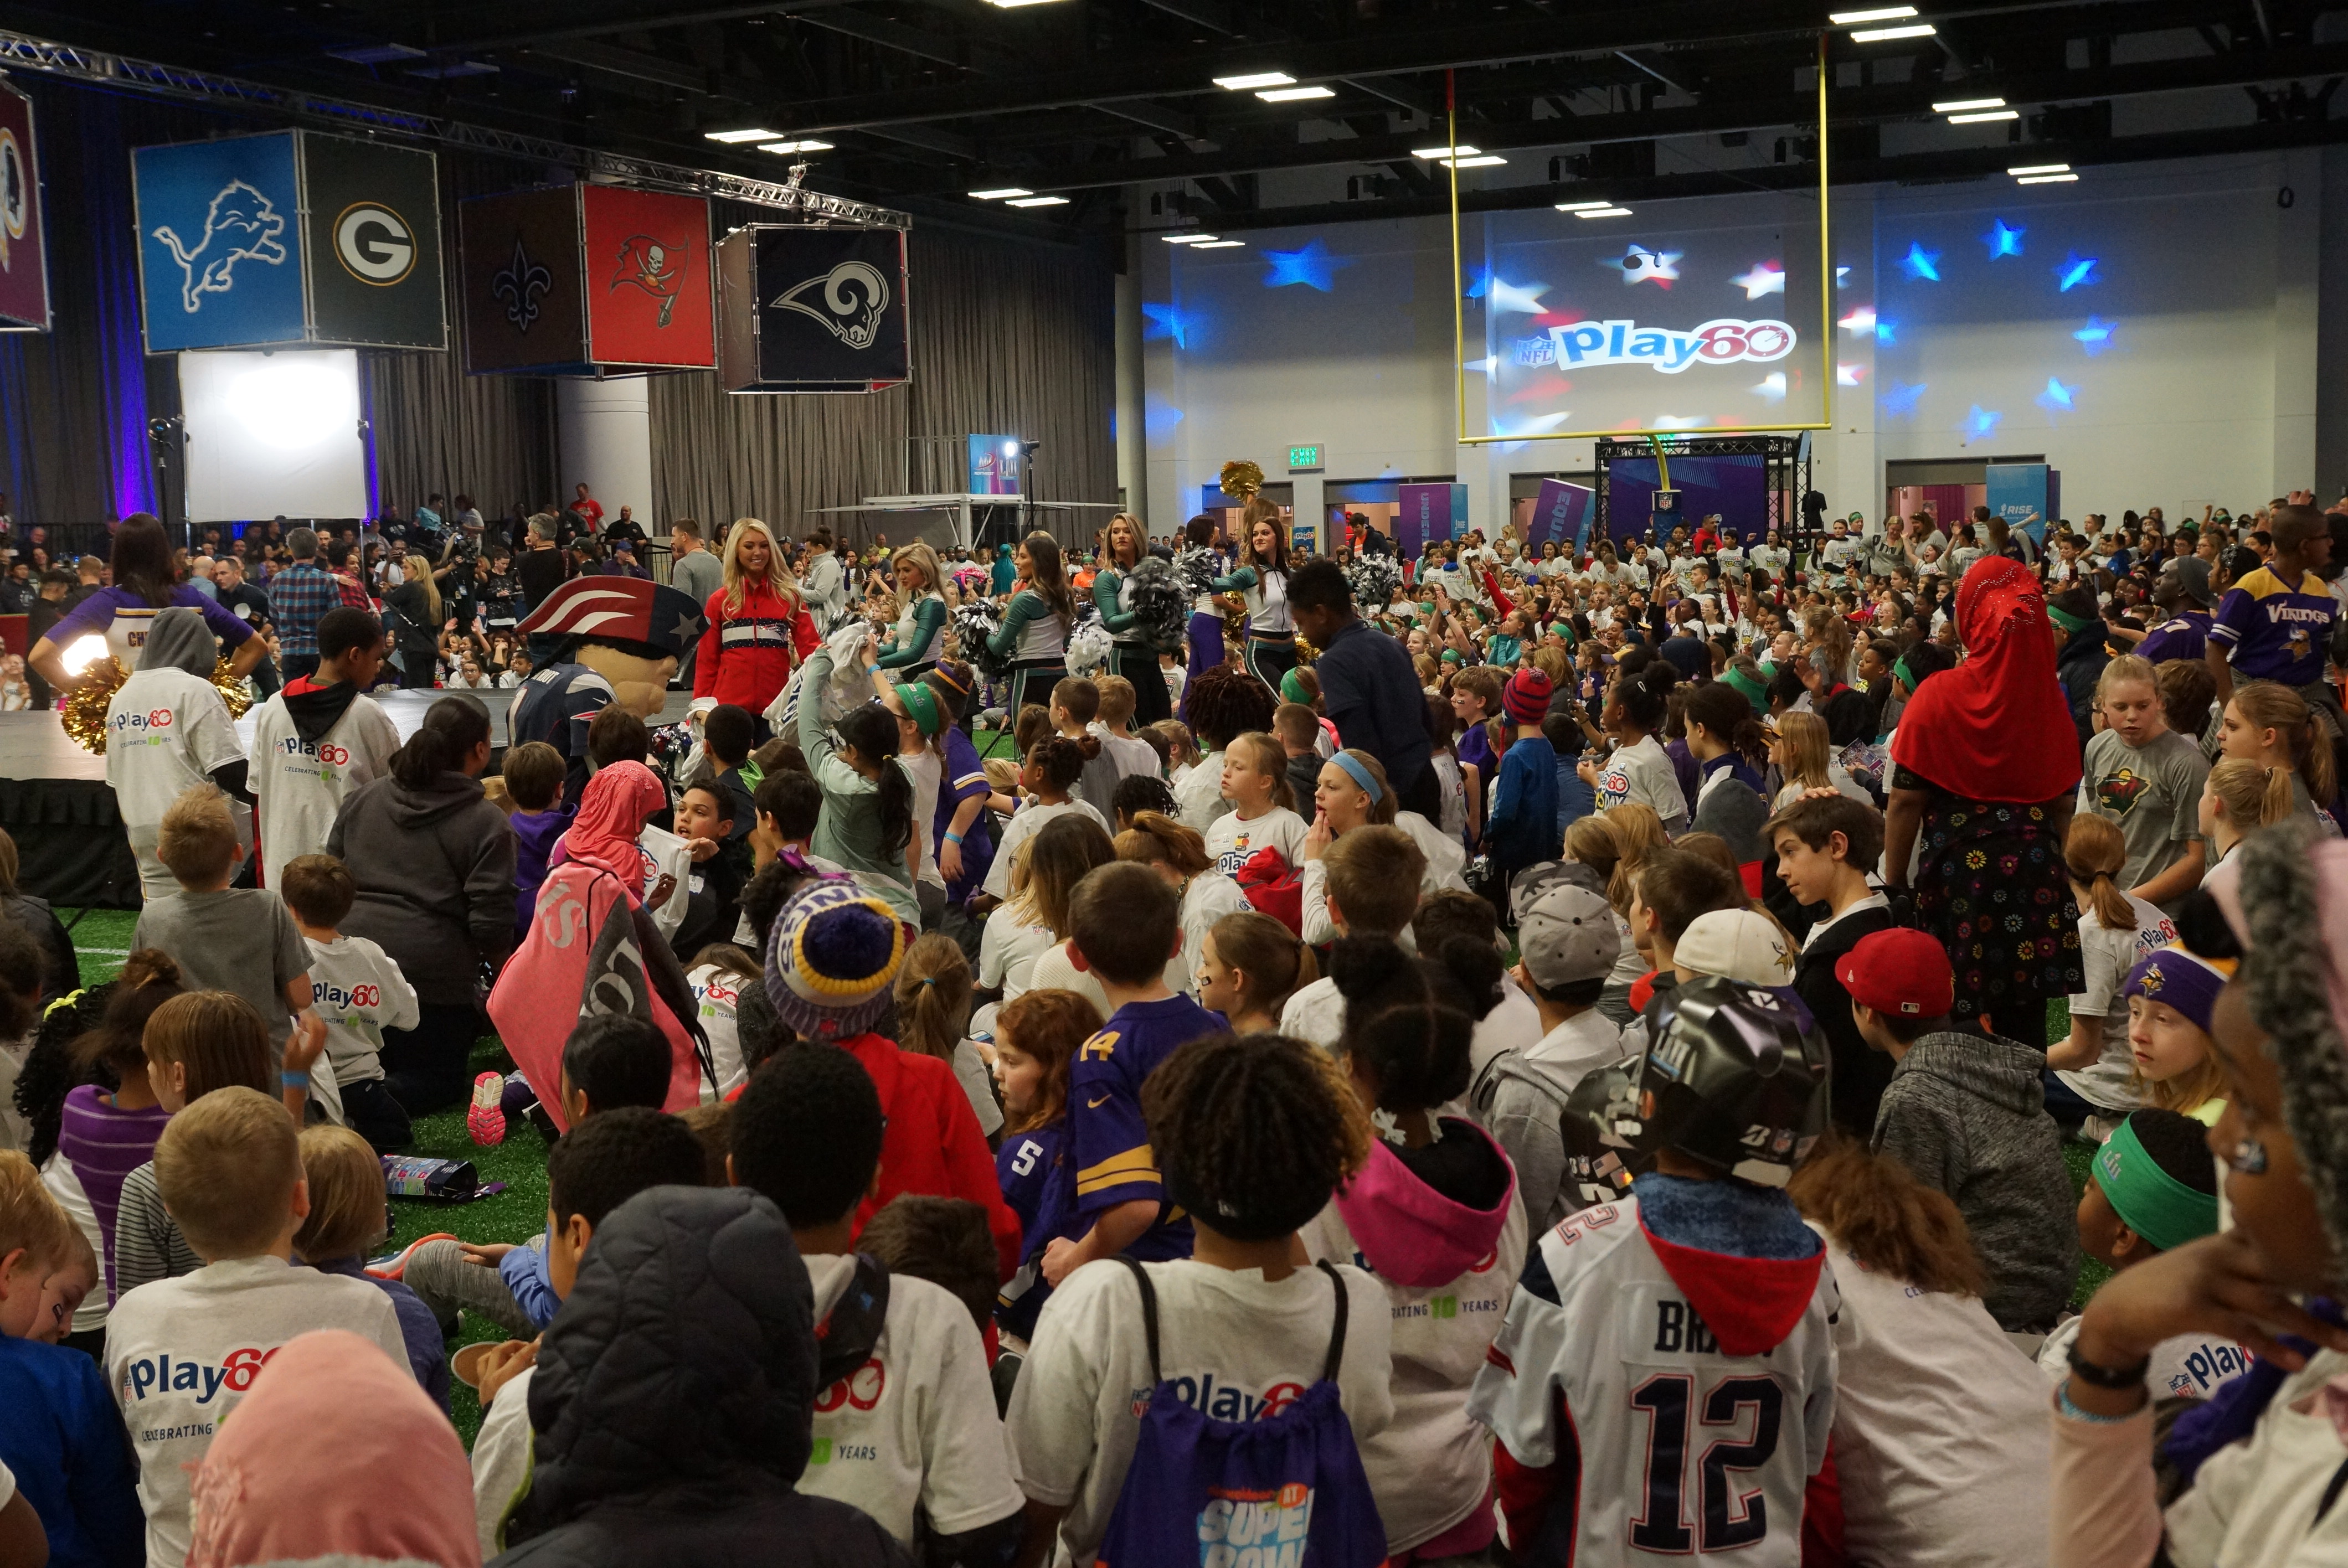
[650,217,1118,542]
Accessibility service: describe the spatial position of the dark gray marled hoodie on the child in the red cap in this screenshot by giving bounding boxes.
[1874,1033,2078,1331]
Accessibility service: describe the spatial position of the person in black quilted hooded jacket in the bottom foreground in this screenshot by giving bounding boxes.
[496,1188,913,1568]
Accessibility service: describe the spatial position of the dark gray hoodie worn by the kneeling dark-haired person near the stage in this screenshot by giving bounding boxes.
[326,772,514,1007]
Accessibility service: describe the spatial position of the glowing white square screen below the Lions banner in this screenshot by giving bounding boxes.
[178,347,366,523]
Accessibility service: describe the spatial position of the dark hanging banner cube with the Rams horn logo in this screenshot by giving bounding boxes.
[718,223,913,392]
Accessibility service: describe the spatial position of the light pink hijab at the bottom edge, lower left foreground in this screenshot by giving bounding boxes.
[188,1329,481,1568]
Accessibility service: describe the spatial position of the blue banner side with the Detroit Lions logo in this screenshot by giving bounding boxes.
[131,131,307,354]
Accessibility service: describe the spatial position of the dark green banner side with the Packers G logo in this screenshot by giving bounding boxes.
[303,131,449,347]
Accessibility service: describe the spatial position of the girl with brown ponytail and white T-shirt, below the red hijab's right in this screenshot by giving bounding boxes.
[2047,814,2176,1122]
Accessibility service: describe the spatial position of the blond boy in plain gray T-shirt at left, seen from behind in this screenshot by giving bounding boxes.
[131,784,326,1065]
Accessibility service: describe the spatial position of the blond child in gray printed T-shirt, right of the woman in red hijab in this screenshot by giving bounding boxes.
[2078,655,2210,913]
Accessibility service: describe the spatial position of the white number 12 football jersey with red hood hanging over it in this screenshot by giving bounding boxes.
[1468,1197,1839,1568]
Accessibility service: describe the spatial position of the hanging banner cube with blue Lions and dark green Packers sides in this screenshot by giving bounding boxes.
[131,131,449,354]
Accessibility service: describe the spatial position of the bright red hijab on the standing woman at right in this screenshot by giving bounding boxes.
[1892,556,2081,803]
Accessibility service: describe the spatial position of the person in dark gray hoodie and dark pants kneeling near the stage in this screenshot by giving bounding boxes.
[326,695,514,1115]
